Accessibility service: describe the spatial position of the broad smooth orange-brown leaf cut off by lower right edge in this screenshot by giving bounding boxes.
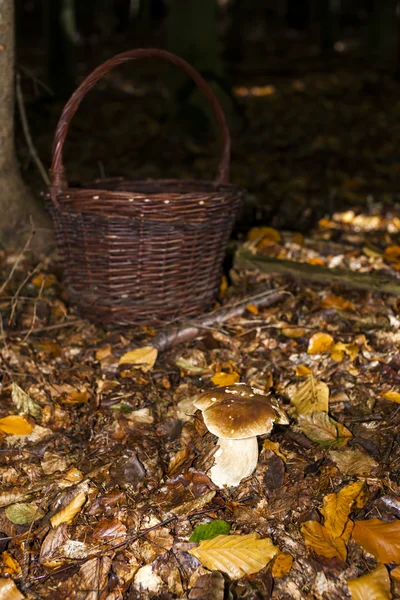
[353,519,400,564]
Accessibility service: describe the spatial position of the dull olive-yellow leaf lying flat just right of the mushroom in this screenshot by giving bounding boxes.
[297,411,352,446]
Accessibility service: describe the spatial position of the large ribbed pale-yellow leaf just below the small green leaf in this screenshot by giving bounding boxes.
[189,533,278,579]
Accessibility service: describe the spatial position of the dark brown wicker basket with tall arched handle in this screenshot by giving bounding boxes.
[48,49,244,325]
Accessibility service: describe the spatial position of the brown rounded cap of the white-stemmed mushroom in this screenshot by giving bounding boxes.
[194,384,277,440]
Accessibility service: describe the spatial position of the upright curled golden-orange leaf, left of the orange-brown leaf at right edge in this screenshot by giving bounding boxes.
[321,481,364,537]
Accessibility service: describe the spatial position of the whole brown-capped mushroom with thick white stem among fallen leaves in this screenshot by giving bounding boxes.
[193,383,288,487]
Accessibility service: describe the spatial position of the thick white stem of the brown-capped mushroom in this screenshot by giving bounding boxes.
[210,436,258,487]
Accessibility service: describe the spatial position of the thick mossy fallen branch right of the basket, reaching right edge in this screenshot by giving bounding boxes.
[234,248,400,296]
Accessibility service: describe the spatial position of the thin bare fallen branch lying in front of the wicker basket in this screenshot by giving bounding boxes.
[151,288,288,352]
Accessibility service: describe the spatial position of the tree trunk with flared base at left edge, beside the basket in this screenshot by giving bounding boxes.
[0,0,52,251]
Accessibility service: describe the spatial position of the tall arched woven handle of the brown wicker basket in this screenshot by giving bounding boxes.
[50,48,231,204]
